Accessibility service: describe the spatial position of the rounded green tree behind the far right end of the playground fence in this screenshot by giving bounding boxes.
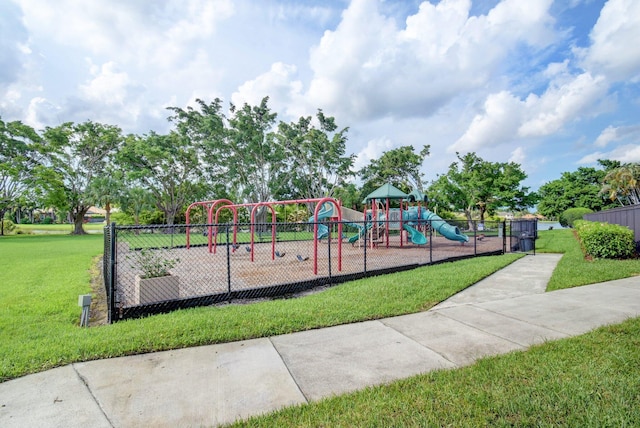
[429,152,537,225]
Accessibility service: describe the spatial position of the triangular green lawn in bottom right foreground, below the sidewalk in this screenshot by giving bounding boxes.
[233,318,640,427]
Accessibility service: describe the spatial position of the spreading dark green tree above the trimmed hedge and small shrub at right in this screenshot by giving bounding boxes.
[538,161,615,220]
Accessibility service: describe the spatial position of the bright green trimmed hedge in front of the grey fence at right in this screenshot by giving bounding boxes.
[575,220,636,259]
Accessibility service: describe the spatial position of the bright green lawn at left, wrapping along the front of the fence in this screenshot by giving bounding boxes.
[0,235,519,380]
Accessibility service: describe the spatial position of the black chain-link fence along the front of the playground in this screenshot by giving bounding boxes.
[103,221,524,322]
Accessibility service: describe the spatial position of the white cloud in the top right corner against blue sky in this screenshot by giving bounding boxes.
[584,0,640,82]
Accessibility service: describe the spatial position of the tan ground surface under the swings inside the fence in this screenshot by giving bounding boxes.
[117,236,503,307]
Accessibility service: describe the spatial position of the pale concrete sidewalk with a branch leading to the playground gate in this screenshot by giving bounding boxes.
[0,254,640,427]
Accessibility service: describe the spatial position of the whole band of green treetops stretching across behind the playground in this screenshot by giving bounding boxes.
[0,97,640,233]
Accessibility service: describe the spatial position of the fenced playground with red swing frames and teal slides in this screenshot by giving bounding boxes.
[110,185,505,318]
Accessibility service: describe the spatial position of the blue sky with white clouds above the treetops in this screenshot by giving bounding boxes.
[0,0,640,190]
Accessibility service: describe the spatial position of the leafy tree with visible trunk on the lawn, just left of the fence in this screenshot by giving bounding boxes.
[39,121,122,235]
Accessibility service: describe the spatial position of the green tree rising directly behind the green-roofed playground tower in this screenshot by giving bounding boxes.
[360,145,431,196]
